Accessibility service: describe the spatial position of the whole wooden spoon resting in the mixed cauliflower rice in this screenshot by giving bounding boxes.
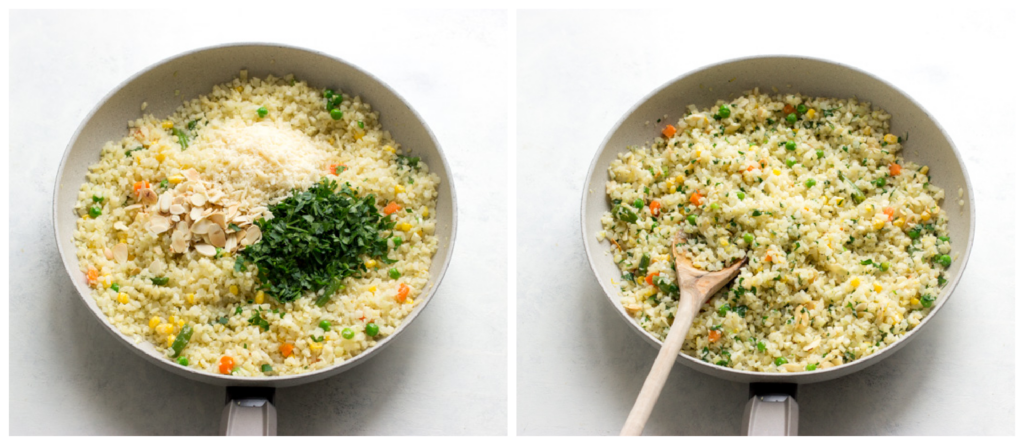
[620,230,746,436]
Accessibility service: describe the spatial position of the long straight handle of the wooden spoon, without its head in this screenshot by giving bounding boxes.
[618,286,701,436]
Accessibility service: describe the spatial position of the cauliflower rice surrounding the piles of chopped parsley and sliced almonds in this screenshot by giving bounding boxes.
[74,71,439,376]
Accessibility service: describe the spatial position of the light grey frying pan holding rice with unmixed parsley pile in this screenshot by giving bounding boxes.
[53,43,457,435]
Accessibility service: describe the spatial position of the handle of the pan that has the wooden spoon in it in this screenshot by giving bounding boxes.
[742,383,800,436]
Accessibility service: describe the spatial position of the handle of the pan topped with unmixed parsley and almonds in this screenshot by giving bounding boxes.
[220,387,278,436]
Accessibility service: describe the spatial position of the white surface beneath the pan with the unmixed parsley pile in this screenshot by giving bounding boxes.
[9,7,511,435]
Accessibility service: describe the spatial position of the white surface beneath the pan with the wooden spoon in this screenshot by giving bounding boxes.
[515,8,1019,435]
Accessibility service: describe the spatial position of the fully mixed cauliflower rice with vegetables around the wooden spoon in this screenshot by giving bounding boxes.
[598,89,951,372]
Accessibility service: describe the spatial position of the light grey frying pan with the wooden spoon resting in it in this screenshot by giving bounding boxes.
[581,56,974,435]
